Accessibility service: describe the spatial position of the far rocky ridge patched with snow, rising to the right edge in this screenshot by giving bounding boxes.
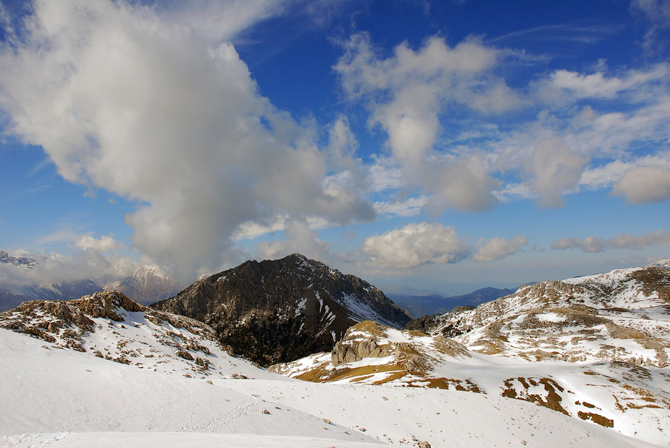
[408,264,670,367]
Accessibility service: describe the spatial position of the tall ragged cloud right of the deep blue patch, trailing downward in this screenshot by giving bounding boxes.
[335,34,524,210]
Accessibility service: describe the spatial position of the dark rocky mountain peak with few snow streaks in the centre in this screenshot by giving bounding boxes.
[152,254,411,366]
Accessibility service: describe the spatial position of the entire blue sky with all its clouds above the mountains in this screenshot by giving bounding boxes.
[0,0,670,295]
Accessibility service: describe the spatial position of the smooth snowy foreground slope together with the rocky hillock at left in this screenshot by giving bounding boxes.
[0,292,660,448]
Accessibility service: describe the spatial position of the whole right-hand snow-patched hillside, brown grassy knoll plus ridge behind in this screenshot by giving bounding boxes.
[271,263,670,446]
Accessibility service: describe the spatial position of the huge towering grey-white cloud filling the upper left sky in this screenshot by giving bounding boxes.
[0,0,374,280]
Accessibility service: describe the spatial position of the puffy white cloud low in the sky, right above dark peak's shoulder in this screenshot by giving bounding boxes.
[361,222,470,269]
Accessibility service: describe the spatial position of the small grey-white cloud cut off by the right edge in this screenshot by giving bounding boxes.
[612,166,670,204]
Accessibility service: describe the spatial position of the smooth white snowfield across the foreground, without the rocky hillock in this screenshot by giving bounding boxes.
[0,329,651,448]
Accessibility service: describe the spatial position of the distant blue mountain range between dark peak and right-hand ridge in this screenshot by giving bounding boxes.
[388,288,514,318]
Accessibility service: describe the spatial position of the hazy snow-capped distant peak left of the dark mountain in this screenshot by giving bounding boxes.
[104,266,182,303]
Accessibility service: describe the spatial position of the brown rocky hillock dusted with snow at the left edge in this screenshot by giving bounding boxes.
[0,291,270,378]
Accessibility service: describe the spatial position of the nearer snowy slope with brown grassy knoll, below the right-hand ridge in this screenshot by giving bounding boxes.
[271,322,670,446]
